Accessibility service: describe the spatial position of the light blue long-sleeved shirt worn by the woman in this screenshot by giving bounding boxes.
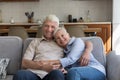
[60,37,105,74]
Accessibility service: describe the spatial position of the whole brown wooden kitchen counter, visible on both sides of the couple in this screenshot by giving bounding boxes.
[0,22,112,53]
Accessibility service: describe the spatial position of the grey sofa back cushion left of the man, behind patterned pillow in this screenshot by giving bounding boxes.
[0,36,23,74]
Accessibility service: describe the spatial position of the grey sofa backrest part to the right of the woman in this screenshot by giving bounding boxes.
[81,37,106,67]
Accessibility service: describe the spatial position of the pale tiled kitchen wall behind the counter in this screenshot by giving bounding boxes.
[0,0,112,22]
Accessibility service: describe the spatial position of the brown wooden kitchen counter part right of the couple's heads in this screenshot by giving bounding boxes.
[64,22,112,53]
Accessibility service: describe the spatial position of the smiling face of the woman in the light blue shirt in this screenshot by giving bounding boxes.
[55,30,70,48]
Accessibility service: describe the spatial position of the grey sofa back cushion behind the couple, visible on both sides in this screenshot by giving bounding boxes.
[23,37,106,66]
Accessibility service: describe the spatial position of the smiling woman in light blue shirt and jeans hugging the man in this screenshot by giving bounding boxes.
[54,28,105,80]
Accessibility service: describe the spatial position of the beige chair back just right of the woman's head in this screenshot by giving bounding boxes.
[65,26,86,37]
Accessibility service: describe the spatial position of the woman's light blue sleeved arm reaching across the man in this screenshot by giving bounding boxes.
[60,38,85,67]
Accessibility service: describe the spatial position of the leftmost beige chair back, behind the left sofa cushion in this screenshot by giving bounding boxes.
[8,27,28,40]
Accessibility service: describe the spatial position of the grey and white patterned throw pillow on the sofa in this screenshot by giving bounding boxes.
[0,58,9,79]
